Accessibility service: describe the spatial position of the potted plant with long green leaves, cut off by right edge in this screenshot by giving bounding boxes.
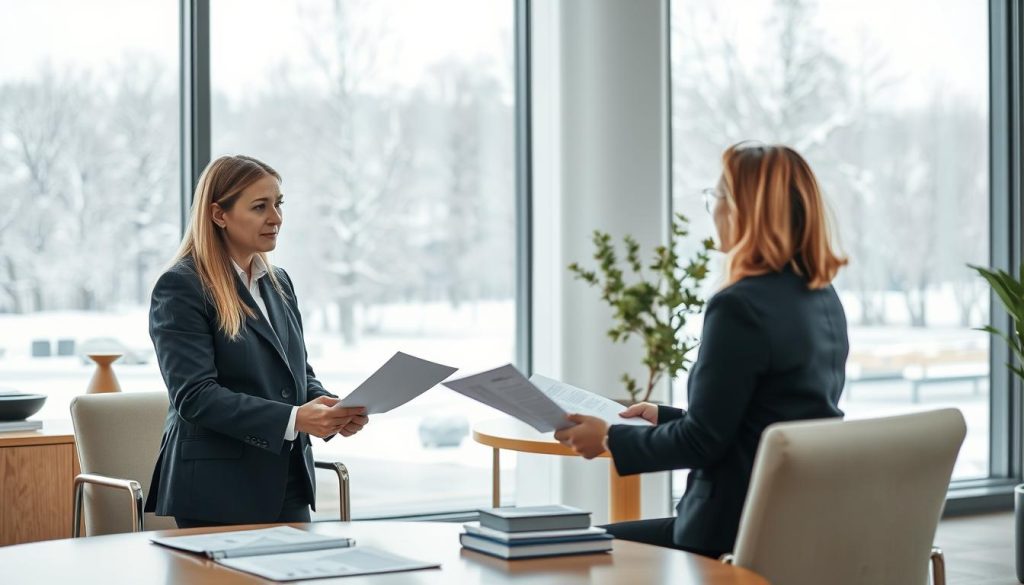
[968,264,1024,583]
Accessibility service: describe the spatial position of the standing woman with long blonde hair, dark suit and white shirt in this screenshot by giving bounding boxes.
[145,156,368,528]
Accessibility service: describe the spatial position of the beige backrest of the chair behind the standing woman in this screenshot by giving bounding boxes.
[69,392,177,536]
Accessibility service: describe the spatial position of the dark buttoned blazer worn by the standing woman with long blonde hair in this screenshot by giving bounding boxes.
[145,259,333,524]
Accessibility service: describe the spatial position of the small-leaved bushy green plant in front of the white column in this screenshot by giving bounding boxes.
[568,213,715,403]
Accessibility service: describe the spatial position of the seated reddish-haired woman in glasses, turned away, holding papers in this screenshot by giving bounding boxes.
[555,142,849,556]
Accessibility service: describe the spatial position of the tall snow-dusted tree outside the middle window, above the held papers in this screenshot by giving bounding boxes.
[292,0,415,344]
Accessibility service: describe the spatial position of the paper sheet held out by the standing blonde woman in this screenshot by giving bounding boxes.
[337,351,458,414]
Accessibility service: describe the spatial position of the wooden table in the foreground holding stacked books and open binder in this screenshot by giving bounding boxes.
[0,521,768,585]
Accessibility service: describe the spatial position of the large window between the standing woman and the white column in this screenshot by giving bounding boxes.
[210,0,516,517]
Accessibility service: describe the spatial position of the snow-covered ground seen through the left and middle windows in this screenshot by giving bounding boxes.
[0,302,515,516]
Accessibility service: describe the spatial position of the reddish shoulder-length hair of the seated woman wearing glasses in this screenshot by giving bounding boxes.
[722,142,848,289]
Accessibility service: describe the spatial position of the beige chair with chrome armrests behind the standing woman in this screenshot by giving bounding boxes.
[71,392,351,538]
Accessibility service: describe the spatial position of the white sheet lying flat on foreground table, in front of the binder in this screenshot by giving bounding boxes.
[217,546,440,581]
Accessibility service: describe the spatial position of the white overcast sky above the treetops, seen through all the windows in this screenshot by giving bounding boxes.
[0,0,988,109]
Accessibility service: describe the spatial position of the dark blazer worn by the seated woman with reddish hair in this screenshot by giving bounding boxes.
[608,269,850,554]
